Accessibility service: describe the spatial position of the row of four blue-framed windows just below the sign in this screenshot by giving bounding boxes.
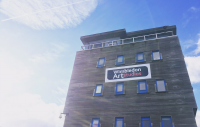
[94,79,167,96]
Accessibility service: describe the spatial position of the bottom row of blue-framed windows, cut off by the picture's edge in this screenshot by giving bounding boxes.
[91,116,173,127]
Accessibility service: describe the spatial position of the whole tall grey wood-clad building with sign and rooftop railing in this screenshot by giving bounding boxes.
[64,26,197,127]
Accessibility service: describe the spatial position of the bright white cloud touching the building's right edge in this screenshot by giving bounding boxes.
[185,56,200,83]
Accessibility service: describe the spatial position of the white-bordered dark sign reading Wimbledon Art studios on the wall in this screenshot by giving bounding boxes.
[105,64,151,82]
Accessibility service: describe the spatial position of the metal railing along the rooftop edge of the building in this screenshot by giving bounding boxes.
[81,31,173,50]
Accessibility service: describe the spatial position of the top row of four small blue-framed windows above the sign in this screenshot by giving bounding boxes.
[97,51,161,67]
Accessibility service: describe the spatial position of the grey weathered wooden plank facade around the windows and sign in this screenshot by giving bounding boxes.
[64,27,197,127]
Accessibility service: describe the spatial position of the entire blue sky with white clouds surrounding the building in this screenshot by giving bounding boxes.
[0,0,200,127]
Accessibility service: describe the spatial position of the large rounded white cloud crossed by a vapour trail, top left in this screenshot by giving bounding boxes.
[0,0,97,29]
